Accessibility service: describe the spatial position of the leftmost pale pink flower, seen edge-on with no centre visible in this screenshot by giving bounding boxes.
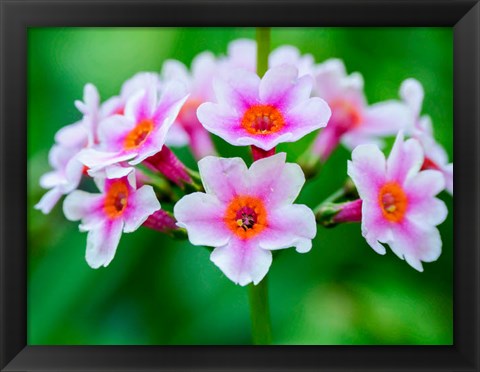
[35,84,100,214]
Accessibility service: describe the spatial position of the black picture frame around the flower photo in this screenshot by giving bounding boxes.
[0,0,480,371]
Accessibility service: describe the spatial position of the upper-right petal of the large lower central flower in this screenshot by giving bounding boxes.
[247,152,305,207]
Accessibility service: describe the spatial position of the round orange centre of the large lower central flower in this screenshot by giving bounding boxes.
[224,196,267,239]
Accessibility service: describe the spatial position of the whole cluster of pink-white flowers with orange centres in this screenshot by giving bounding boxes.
[36,39,453,286]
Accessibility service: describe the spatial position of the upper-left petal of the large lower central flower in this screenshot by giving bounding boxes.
[198,156,247,202]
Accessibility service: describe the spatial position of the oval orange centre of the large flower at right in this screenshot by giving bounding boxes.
[378,182,408,222]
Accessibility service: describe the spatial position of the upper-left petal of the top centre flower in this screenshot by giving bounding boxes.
[213,69,260,115]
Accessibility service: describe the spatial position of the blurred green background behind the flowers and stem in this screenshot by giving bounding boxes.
[27,28,453,345]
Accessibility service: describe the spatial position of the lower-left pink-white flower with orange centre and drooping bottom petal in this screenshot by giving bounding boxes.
[63,173,160,269]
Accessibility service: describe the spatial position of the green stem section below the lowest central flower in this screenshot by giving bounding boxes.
[248,277,272,345]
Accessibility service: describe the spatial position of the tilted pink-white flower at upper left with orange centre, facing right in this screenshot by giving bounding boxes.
[79,82,188,178]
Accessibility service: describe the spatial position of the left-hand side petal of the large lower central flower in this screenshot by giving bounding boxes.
[173,192,232,247]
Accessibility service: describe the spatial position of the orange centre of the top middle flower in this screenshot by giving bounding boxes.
[242,105,285,134]
